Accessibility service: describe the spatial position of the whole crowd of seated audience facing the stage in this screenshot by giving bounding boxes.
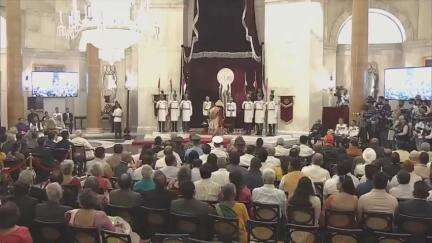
[0,134,432,242]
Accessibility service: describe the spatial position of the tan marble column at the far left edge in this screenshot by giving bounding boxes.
[6,0,24,126]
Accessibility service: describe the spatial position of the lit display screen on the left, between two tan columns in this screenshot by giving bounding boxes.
[31,72,79,97]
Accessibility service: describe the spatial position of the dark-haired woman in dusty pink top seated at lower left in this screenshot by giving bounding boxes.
[66,188,116,232]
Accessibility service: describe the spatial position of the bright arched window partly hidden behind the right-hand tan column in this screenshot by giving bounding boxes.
[338,8,405,45]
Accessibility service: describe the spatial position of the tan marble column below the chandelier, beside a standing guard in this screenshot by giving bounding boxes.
[87,44,102,133]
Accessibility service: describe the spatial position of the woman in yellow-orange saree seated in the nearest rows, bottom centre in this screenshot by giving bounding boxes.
[215,183,249,243]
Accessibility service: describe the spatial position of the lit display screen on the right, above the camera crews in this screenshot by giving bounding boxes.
[384,67,432,100]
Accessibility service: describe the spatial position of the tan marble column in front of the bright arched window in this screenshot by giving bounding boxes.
[350,0,369,116]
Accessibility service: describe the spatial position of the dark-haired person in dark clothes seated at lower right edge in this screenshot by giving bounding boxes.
[398,181,432,218]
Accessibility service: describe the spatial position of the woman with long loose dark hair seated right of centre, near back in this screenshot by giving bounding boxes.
[288,177,321,225]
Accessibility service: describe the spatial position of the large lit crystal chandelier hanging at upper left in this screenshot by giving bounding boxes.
[57,0,158,65]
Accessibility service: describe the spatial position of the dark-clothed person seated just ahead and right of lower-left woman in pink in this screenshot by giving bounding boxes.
[109,174,141,208]
